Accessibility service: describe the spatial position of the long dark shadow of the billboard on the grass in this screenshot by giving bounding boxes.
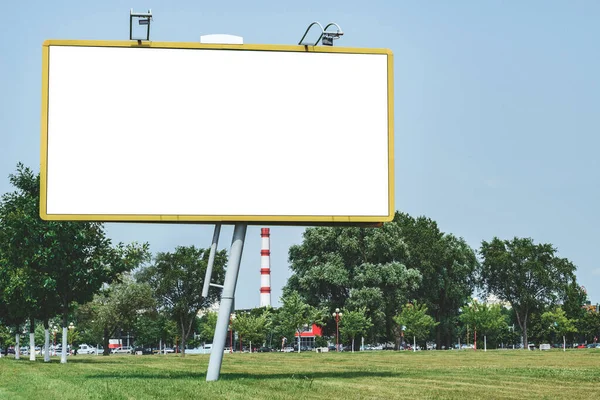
[86,371,402,380]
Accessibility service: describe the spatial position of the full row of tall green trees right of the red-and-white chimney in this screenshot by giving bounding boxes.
[284,212,600,349]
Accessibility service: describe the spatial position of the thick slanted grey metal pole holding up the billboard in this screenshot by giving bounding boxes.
[206,223,248,382]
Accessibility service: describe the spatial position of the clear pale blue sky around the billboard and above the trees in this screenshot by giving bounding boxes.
[0,0,600,308]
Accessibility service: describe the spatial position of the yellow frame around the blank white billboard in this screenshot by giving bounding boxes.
[40,40,395,225]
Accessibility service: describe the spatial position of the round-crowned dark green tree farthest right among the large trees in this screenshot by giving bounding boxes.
[480,237,575,348]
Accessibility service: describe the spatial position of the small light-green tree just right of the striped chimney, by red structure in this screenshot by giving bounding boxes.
[278,292,324,353]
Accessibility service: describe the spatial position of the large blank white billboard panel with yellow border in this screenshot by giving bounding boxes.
[40,40,394,225]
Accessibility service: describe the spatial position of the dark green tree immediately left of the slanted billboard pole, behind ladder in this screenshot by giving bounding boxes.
[137,246,227,356]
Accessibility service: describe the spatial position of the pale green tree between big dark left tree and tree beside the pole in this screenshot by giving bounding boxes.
[78,276,154,355]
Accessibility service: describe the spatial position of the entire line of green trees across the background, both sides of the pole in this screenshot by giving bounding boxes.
[0,164,600,362]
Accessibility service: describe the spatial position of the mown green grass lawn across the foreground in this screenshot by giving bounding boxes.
[0,349,600,400]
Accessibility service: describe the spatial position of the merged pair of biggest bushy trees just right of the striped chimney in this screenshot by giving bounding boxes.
[285,213,478,345]
